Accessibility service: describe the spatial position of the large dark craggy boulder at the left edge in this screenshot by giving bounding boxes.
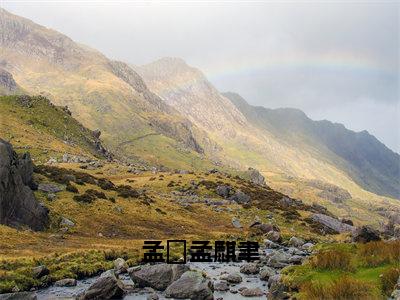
[0,139,49,230]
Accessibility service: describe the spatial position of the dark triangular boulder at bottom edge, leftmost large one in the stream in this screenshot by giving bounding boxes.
[82,270,124,300]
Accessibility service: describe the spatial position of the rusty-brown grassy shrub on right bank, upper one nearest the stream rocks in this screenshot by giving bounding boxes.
[310,249,353,271]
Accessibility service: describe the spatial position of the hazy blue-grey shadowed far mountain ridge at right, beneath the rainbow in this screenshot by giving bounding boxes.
[224,93,400,198]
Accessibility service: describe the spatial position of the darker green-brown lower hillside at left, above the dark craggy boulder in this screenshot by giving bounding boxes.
[0,96,109,163]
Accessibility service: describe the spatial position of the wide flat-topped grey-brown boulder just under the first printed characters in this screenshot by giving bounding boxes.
[129,264,189,291]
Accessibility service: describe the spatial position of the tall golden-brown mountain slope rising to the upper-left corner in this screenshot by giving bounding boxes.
[0,9,211,170]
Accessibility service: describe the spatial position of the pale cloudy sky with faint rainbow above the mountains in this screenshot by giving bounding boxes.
[0,0,400,153]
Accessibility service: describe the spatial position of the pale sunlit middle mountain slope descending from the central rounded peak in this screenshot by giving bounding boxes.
[135,58,399,222]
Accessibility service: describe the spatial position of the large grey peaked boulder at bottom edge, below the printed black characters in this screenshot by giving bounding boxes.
[165,271,213,300]
